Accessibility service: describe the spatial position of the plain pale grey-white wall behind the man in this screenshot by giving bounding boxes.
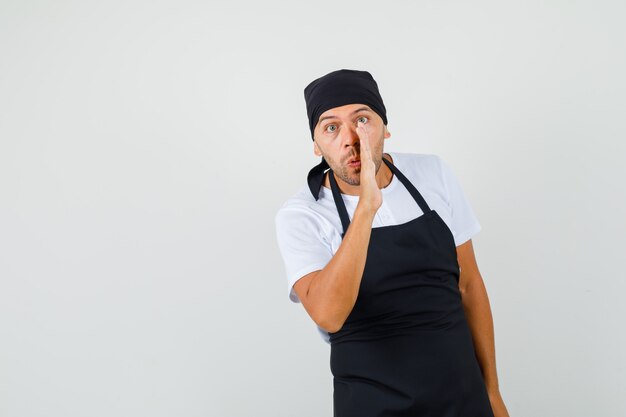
[0,0,626,417]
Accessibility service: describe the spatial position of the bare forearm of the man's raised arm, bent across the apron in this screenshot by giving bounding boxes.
[307,205,375,332]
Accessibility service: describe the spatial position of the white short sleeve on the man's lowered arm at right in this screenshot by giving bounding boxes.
[438,157,482,246]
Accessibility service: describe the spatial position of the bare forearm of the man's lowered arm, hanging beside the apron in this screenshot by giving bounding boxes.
[462,277,499,391]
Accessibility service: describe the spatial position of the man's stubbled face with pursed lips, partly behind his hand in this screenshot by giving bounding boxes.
[313,104,391,186]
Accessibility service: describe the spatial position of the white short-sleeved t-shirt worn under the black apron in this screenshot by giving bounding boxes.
[275,152,481,343]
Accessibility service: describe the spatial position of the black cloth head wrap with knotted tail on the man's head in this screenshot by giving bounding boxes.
[304,69,387,200]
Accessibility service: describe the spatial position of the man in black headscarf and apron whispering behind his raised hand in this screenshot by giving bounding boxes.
[276,69,508,417]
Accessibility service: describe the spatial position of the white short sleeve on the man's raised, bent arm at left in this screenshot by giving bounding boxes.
[275,207,333,303]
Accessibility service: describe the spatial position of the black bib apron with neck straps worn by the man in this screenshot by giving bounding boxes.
[329,158,493,417]
